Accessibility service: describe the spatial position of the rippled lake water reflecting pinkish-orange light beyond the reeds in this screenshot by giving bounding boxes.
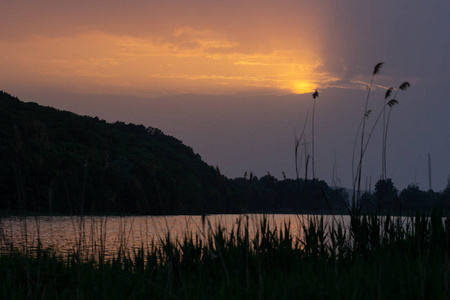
[0,214,349,256]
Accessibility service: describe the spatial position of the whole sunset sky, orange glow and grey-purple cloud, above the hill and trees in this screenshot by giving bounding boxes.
[0,0,450,190]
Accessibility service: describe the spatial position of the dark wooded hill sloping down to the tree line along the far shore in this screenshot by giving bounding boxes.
[0,91,450,214]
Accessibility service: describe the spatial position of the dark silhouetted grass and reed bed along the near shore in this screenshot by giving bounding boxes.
[0,210,450,299]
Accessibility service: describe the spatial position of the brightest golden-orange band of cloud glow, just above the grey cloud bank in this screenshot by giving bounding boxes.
[0,27,330,96]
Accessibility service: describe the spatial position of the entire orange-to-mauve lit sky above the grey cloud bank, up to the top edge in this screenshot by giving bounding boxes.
[0,0,420,96]
